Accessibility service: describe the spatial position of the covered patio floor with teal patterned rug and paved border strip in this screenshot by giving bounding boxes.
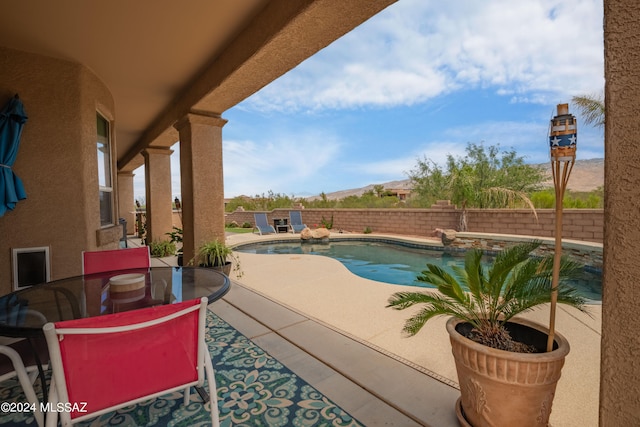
[0,239,458,427]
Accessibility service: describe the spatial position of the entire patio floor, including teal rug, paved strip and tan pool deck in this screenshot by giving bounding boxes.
[0,234,601,427]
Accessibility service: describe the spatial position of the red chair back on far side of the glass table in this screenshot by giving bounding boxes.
[82,246,151,274]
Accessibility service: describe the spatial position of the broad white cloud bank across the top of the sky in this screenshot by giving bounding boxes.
[242,0,604,111]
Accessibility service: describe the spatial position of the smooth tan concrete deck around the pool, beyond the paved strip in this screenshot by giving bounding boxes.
[227,234,602,427]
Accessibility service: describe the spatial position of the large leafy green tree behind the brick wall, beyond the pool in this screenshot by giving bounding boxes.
[408,143,544,231]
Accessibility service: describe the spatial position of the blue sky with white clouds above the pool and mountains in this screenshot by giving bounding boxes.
[134,0,604,200]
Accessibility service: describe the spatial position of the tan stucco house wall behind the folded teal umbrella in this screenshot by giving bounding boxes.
[0,48,117,294]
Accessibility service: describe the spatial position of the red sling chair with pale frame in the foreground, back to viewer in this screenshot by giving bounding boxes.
[43,298,219,426]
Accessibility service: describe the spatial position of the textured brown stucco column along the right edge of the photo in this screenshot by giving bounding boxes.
[600,0,640,426]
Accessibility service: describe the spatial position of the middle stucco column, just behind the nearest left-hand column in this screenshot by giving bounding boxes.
[142,148,173,244]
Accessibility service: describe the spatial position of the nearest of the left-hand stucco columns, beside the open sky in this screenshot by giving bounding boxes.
[175,114,227,264]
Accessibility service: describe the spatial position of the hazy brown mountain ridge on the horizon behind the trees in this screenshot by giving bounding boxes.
[306,159,604,201]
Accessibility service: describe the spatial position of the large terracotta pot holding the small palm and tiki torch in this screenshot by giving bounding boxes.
[447,318,569,427]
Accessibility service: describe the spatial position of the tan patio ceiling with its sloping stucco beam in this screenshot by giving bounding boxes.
[0,0,396,171]
